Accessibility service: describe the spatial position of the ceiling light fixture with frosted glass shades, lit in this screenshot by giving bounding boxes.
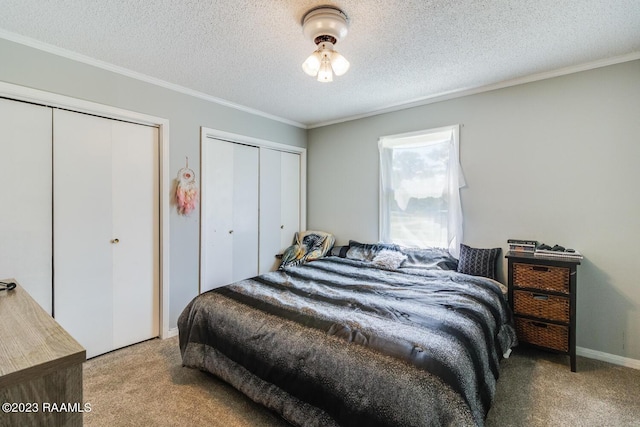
[302,6,349,82]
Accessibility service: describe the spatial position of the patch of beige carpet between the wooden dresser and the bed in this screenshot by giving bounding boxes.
[84,337,288,427]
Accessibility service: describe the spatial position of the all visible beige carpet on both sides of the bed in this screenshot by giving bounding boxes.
[84,338,640,427]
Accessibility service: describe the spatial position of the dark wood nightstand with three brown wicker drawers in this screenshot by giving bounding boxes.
[505,252,580,372]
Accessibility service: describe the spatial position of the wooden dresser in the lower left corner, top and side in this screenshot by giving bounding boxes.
[0,279,90,427]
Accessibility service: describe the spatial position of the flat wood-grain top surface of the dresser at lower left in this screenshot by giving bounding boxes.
[0,279,86,389]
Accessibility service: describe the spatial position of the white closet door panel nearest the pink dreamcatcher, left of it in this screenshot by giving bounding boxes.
[111,121,160,348]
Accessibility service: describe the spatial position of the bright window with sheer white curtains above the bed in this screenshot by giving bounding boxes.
[378,125,464,257]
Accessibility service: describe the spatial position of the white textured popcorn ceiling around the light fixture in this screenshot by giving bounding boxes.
[0,0,640,127]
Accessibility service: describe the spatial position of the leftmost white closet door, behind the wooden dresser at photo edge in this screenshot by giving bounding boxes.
[0,99,52,314]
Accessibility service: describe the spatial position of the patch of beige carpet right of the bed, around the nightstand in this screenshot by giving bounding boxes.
[487,349,640,427]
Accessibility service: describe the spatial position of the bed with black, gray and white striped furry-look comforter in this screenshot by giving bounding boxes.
[178,242,516,426]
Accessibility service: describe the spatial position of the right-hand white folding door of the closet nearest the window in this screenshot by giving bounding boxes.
[260,148,300,274]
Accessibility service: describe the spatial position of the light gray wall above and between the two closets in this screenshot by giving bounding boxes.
[0,39,306,328]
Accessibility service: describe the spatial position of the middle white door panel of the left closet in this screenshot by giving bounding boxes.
[53,110,113,357]
